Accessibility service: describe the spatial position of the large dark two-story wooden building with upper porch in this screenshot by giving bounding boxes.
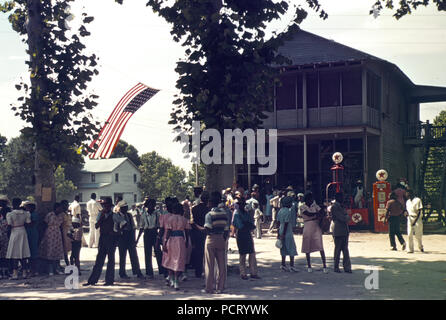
[236,30,446,200]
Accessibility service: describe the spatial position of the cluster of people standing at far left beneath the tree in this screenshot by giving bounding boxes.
[0,195,82,280]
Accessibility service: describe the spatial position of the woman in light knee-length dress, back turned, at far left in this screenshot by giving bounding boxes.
[6,198,31,280]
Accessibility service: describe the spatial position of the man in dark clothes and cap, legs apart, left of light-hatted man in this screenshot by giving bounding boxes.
[84,197,118,286]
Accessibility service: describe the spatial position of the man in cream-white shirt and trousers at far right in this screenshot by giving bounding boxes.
[406,190,424,253]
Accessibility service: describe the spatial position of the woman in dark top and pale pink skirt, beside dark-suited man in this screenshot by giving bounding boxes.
[299,191,328,273]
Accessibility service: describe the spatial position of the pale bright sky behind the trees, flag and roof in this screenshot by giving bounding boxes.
[0,0,446,170]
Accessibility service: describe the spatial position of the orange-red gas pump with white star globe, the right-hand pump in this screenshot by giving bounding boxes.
[373,169,391,232]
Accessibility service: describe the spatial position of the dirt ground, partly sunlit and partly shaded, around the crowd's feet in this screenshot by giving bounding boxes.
[0,232,446,300]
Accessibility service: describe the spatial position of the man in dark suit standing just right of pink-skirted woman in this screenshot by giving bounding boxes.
[330,193,352,273]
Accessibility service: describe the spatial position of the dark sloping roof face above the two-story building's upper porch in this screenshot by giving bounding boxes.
[279,30,385,65]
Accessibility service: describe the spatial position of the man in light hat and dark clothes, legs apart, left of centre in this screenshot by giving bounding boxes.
[115,200,144,279]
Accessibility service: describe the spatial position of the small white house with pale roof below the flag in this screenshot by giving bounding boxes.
[76,158,141,206]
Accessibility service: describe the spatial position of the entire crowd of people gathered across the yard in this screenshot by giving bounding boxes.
[0,179,423,293]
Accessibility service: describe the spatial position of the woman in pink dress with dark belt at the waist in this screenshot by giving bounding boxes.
[163,203,191,290]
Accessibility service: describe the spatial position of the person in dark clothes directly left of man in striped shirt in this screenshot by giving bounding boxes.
[190,191,209,278]
